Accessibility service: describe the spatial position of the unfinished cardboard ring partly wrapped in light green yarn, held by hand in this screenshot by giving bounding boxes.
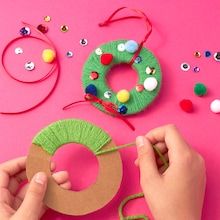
[26,119,122,216]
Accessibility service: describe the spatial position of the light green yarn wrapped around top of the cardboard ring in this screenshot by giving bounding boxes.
[33,119,111,155]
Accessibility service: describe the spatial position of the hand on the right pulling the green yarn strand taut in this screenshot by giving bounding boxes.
[136,125,206,220]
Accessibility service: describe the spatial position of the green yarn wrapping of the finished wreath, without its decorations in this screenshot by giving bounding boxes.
[82,40,162,115]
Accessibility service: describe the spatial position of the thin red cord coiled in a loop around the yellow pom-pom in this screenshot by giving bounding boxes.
[0,22,60,114]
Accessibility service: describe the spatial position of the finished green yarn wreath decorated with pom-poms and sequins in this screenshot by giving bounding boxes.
[82,40,162,115]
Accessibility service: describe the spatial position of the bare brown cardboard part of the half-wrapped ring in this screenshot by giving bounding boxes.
[26,121,122,216]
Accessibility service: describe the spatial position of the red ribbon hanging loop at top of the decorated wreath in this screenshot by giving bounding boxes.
[99,7,152,65]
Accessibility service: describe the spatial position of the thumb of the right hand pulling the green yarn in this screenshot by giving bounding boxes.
[136,136,160,187]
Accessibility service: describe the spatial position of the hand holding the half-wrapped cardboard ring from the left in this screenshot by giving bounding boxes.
[0,157,71,220]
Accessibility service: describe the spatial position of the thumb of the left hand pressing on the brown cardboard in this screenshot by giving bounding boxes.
[17,172,47,220]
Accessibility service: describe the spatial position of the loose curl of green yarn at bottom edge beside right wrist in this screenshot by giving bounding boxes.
[118,193,149,220]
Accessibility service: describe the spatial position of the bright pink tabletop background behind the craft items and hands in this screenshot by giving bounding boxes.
[0,0,220,220]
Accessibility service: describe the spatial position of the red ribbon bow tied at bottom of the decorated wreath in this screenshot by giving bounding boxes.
[63,93,135,131]
